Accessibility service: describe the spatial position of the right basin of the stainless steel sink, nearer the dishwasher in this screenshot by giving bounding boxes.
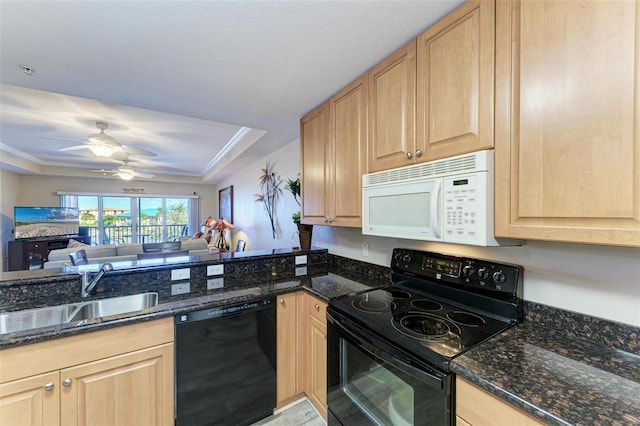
[69,293,158,321]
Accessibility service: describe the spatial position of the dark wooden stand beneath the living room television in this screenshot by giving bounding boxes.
[9,235,91,271]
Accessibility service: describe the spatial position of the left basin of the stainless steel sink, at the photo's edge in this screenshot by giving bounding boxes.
[0,305,76,334]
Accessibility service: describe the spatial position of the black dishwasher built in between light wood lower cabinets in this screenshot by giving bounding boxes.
[175,298,276,426]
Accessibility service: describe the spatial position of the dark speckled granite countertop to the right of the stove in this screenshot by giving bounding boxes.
[452,321,640,425]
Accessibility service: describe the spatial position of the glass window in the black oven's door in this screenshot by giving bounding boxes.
[340,339,415,425]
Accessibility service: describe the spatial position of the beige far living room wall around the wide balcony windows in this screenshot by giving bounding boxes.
[0,170,218,271]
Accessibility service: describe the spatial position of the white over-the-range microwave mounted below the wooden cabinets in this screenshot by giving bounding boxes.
[362,150,520,246]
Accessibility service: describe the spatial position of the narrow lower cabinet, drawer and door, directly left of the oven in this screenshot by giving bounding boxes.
[298,293,327,419]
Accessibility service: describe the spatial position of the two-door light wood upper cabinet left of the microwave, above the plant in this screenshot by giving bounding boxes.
[300,78,367,227]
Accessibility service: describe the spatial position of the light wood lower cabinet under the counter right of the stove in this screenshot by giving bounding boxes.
[456,377,544,426]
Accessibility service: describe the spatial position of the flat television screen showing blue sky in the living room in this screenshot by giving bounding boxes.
[13,207,80,240]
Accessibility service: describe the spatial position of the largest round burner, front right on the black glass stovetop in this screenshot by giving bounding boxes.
[391,312,460,341]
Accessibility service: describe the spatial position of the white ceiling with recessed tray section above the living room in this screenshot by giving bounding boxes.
[0,0,462,183]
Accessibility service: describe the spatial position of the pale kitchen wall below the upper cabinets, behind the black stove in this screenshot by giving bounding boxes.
[313,226,640,326]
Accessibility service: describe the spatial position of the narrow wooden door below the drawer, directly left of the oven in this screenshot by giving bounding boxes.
[307,316,327,419]
